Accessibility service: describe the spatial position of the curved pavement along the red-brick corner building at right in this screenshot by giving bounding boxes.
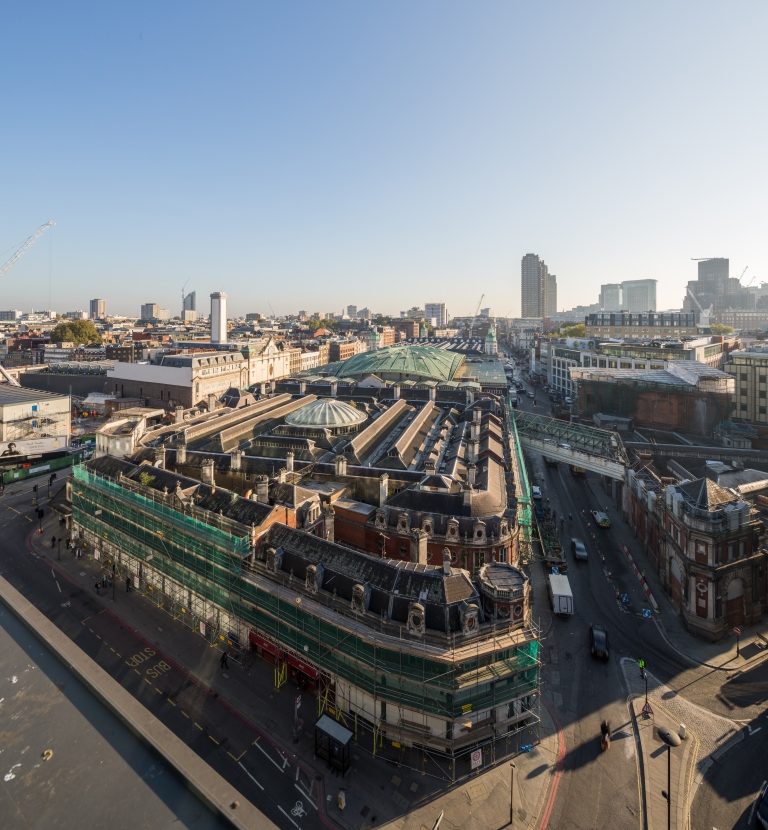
[590,484,768,671]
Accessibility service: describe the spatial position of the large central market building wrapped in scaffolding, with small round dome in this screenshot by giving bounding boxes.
[68,348,540,781]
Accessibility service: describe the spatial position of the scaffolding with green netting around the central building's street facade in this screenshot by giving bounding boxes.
[72,465,540,780]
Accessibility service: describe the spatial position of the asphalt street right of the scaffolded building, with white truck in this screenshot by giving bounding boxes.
[510,380,768,830]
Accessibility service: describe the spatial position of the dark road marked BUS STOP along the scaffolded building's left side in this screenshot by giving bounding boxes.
[0,484,322,830]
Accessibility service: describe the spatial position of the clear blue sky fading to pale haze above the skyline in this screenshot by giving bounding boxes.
[0,0,768,316]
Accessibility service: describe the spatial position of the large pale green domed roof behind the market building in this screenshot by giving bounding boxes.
[335,346,464,381]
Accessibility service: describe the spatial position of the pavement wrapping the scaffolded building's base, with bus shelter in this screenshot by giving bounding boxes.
[29,500,560,830]
